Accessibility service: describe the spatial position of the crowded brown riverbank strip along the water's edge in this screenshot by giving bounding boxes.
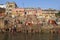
[0,28,60,34]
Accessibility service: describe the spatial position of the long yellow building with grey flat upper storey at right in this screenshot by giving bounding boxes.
[42,8,59,20]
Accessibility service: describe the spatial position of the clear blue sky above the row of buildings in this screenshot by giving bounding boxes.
[0,0,60,10]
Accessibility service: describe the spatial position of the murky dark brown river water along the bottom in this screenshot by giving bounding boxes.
[0,32,60,40]
